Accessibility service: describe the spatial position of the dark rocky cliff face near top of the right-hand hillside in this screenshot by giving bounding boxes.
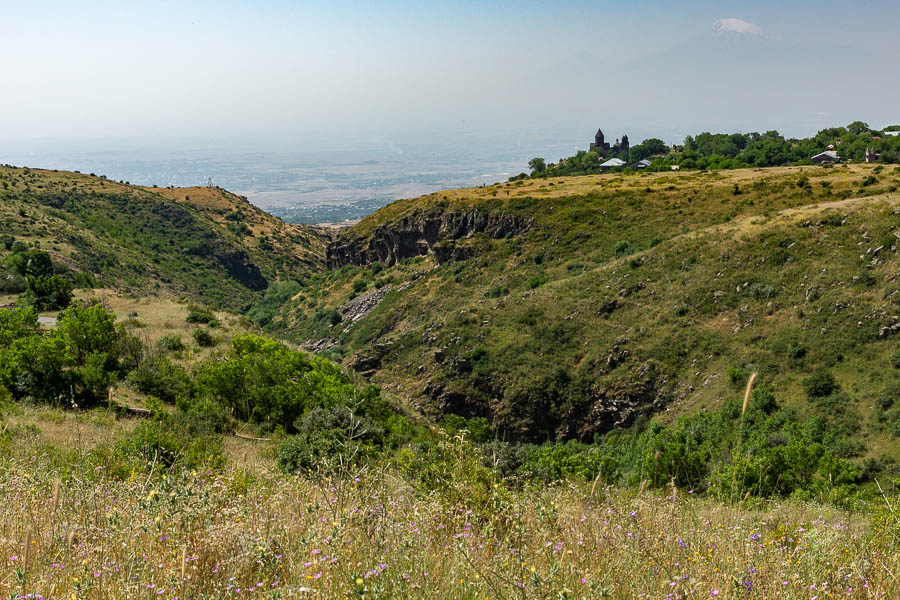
[326,209,531,269]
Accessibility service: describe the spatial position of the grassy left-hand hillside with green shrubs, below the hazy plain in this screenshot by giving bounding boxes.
[0,167,324,308]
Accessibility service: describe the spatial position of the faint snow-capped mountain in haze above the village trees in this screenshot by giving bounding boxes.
[623,19,900,132]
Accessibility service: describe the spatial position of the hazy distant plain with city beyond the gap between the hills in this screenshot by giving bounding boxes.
[0,134,573,224]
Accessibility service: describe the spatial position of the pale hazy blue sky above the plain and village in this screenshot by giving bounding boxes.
[0,0,900,147]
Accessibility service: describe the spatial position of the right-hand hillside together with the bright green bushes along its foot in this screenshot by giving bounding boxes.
[246,166,900,502]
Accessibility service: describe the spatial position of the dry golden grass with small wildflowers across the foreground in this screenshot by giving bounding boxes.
[0,424,900,600]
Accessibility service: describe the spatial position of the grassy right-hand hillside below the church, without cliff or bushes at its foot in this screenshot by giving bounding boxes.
[281,165,900,455]
